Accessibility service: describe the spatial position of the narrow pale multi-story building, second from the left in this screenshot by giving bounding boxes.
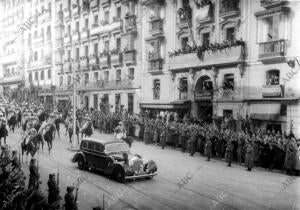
[24,0,55,105]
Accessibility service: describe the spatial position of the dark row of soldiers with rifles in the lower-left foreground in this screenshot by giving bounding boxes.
[0,145,78,210]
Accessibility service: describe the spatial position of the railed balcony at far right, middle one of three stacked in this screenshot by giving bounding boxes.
[258,39,286,61]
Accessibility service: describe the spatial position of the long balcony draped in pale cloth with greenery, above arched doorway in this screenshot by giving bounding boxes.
[169,45,244,70]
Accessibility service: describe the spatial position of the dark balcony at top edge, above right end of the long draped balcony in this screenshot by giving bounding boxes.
[220,0,240,18]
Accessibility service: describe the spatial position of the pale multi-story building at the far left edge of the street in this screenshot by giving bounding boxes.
[0,0,24,100]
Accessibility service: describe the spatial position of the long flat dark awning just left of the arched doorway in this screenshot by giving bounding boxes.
[140,101,190,109]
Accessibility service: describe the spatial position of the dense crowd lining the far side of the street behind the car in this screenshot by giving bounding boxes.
[72,110,300,175]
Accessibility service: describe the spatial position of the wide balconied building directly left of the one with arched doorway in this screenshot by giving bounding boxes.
[56,0,142,113]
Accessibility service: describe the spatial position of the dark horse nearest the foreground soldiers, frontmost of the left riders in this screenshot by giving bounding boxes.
[21,133,44,162]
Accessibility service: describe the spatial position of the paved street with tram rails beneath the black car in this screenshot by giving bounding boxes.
[7,129,300,210]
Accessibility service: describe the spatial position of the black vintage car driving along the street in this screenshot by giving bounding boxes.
[72,138,157,183]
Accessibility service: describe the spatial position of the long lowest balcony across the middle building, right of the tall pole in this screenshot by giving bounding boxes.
[79,80,133,91]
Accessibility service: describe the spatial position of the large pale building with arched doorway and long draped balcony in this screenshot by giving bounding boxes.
[141,0,300,135]
